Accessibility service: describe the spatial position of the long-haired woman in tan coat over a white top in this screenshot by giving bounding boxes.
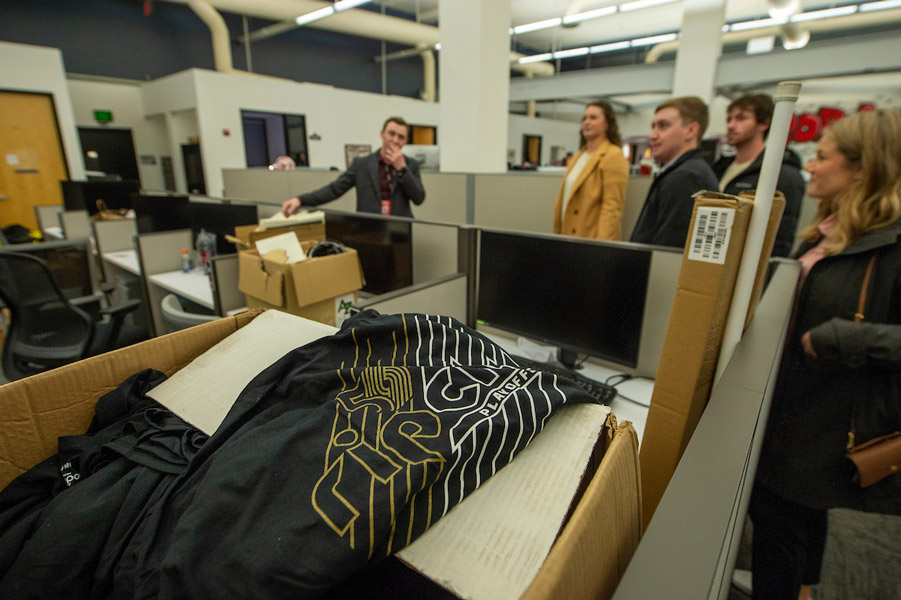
[554,101,629,240]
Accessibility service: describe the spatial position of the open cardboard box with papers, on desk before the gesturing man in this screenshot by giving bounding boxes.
[238,241,363,325]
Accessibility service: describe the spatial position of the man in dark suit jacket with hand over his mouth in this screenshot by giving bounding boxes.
[282,117,425,217]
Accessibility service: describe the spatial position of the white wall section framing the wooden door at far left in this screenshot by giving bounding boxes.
[0,42,84,179]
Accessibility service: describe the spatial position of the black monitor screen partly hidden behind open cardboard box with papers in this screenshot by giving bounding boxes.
[325,213,413,294]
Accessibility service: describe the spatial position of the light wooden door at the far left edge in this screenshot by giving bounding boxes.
[0,91,69,229]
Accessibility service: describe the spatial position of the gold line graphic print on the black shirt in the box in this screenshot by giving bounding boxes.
[313,367,445,555]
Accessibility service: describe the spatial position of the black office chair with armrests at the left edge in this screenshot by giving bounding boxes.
[0,250,147,380]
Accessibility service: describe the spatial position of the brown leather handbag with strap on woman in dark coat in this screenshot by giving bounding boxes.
[845,253,901,487]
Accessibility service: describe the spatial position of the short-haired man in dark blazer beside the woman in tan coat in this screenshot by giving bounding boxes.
[629,96,717,248]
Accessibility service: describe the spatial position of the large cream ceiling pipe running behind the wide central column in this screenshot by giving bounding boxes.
[168,0,555,75]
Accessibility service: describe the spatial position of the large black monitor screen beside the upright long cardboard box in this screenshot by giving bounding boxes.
[476,231,651,367]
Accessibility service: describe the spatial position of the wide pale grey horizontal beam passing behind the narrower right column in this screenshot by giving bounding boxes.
[510,34,901,101]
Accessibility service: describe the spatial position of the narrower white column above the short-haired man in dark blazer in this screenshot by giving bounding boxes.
[673,0,726,104]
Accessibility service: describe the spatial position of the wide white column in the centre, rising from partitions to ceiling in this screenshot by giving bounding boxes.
[438,0,510,173]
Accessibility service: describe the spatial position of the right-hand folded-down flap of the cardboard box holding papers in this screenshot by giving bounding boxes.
[291,248,363,306]
